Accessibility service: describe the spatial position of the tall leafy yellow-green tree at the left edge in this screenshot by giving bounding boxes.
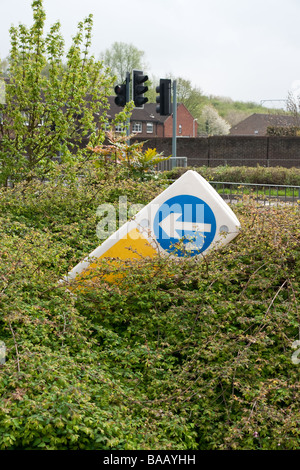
[0,0,119,184]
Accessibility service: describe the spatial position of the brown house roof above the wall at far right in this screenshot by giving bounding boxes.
[230,113,297,135]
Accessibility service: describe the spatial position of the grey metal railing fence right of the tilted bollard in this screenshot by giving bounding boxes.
[210,181,300,207]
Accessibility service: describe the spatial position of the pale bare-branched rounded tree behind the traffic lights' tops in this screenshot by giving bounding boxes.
[100,42,145,82]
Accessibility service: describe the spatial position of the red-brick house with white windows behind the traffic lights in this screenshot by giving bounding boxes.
[108,96,198,138]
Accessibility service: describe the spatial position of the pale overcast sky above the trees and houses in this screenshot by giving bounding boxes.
[0,0,300,107]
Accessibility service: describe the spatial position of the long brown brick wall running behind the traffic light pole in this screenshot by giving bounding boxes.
[134,136,300,168]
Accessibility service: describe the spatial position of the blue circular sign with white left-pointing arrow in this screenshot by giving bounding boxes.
[153,194,216,256]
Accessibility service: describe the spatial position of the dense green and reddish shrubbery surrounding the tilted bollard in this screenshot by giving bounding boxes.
[0,163,300,450]
